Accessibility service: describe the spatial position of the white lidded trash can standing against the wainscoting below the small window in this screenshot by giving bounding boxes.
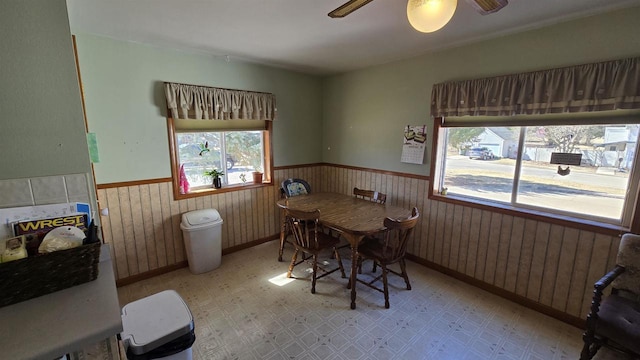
[180,209,222,274]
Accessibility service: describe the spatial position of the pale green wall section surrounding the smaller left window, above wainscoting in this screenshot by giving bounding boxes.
[76,33,322,184]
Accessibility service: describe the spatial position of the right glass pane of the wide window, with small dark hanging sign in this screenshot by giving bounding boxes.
[517,125,638,220]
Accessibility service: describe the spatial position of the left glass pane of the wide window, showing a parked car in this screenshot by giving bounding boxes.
[444,127,520,203]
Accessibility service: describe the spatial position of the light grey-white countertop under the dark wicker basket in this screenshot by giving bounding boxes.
[0,244,122,360]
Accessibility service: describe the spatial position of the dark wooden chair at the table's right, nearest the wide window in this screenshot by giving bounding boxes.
[349,207,420,309]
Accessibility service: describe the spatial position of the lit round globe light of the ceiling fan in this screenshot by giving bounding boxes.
[407,0,458,33]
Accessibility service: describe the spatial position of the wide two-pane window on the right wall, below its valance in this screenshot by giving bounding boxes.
[434,121,640,226]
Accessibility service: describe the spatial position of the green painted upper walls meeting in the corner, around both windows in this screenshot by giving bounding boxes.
[76,7,640,184]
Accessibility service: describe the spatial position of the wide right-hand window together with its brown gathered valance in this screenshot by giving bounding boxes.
[431,58,640,230]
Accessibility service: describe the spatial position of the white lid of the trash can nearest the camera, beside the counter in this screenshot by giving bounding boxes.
[120,290,193,355]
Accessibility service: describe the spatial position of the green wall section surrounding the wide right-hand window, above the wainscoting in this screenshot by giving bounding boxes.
[322,7,640,175]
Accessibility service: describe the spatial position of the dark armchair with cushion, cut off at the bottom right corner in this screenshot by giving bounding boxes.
[580,234,640,360]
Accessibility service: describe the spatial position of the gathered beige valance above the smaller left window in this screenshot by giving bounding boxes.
[164,82,277,120]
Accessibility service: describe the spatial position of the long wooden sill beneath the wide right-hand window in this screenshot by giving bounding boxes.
[429,193,629,236]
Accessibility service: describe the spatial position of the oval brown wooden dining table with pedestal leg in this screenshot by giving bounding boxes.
[277,192,411,309]
